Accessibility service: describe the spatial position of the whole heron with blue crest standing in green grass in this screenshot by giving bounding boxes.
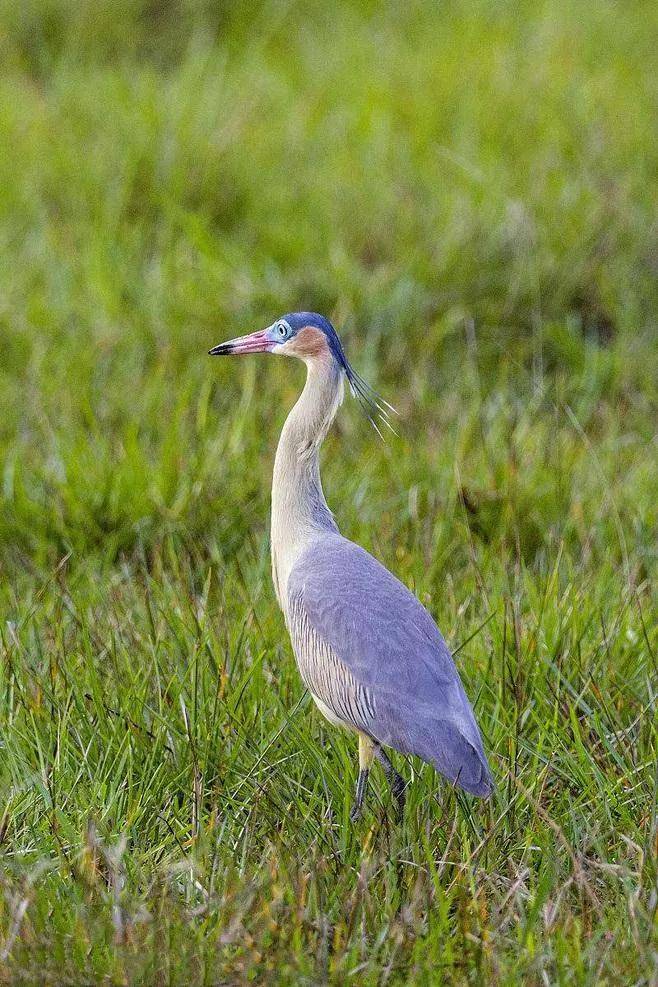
[210,312,492,820]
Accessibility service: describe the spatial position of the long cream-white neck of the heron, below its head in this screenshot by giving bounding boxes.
[272,358,343,612]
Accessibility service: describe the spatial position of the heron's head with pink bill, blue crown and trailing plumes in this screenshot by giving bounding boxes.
[209,312,395,435]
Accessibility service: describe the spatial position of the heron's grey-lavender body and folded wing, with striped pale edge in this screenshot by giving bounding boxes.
[287,533,491,795]
